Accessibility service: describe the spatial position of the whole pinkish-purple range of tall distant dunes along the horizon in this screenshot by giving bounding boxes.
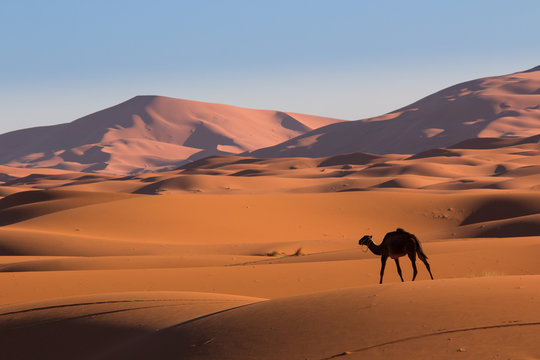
[0,66,540,175]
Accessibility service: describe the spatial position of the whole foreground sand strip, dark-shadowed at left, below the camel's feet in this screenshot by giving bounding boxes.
[0,276,540,359]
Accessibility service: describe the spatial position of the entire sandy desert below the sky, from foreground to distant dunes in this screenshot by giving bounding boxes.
[0,68,540,360]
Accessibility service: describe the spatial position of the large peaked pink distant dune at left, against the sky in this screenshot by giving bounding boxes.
[0,96,341,174]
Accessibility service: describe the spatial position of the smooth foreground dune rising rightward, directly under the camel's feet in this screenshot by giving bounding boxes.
[107,276,540,359]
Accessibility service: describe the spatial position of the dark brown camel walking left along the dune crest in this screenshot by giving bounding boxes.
[358,228,433,284]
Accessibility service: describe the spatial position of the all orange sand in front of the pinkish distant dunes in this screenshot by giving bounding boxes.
[0,148,540,359]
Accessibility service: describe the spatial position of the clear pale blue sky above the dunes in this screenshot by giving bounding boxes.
[0,0,540,133]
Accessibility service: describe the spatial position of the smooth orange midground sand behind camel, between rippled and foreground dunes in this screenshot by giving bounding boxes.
[0,189,540,303]
